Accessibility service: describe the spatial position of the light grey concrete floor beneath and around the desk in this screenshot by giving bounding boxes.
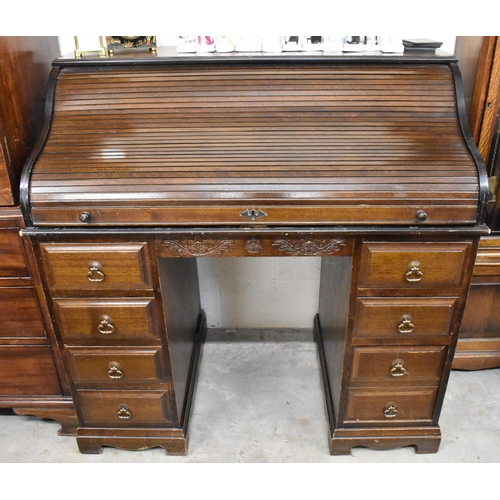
[0,330,500,463]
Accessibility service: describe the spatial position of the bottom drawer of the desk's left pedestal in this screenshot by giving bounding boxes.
[77,390,177,427]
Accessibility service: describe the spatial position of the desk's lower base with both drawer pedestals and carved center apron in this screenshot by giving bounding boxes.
[26,229,478,454]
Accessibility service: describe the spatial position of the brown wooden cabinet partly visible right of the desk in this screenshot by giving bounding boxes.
[453,36,500,370]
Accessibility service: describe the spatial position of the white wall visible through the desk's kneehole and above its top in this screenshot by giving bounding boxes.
[55,35,455,329]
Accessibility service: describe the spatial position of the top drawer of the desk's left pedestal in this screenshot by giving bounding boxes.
[40,243,152,295]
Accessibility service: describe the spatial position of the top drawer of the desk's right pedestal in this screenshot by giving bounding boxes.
[358,242,472,295]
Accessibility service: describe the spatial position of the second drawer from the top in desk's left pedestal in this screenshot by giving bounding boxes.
[54,298,160,345]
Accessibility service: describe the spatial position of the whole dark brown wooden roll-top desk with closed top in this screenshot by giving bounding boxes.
[21,48,487,454]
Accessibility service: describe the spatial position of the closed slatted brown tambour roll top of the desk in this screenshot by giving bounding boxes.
[25,58,479,225]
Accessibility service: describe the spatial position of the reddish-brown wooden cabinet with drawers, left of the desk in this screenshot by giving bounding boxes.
[0,37,76,434]
